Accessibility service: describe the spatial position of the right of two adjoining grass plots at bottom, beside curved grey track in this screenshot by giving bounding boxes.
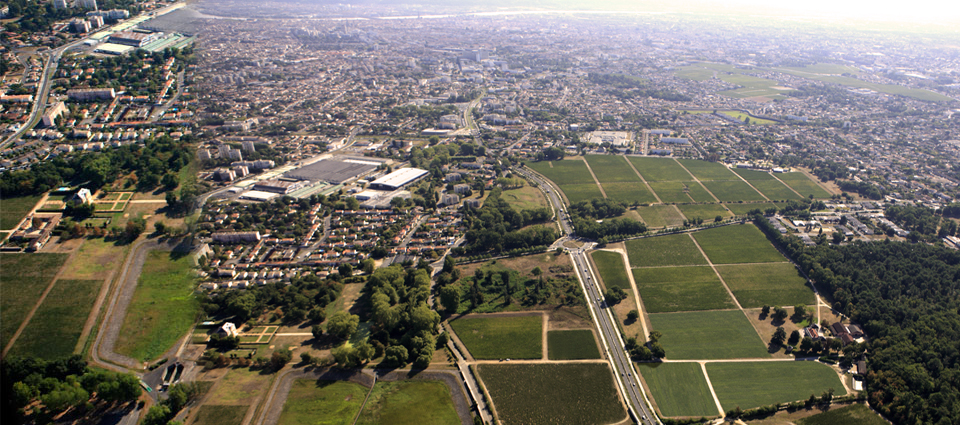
[356,381,460,425]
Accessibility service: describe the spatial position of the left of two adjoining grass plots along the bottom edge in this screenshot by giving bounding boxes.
[279,379,367,425]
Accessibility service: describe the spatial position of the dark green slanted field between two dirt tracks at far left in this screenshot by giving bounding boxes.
[10,279,103,360]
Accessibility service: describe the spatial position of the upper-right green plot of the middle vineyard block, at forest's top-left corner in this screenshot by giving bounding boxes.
[693,224,784,264]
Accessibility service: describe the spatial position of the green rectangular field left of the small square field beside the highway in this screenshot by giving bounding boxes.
[450,315,543,360]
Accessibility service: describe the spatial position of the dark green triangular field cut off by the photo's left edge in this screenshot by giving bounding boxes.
[0,253,67,347]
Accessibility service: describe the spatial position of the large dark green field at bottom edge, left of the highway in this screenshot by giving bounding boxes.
[477,363,626,424]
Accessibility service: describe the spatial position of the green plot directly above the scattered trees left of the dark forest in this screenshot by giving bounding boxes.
[717,263,814,308]
